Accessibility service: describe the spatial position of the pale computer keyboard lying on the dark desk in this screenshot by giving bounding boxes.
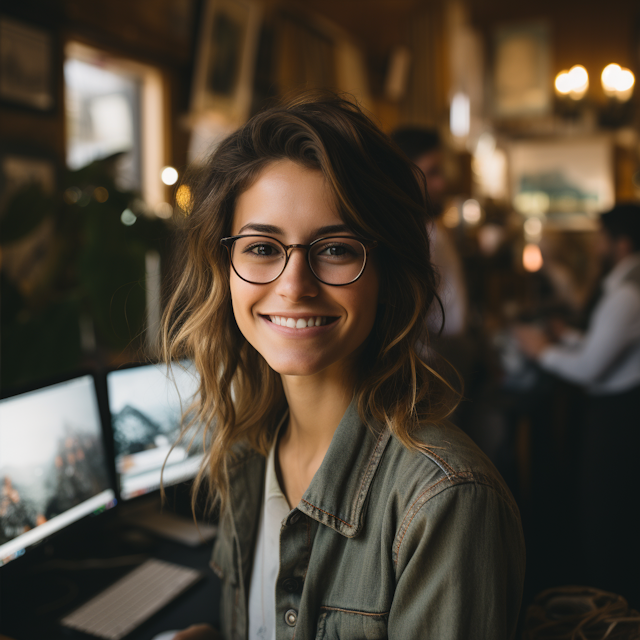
[60,559,203,640]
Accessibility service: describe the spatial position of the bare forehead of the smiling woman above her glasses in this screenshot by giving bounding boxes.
[232,160,342,235]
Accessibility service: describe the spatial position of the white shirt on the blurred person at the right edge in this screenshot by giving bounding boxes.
[539,253,640,395]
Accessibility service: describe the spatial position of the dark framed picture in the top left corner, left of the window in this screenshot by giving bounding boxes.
[0,16,55,111]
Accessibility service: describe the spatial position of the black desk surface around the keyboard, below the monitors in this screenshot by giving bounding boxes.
[0,521,221,640]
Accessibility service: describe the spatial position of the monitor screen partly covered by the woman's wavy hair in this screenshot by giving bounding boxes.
[107,363,202,500]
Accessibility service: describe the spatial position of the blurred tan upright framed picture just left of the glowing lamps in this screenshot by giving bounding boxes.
[493,23,552,118]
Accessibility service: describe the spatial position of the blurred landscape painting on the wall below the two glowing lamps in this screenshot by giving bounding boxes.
[509,136,615,227]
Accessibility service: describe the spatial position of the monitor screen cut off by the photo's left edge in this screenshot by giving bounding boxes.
[0,375,115,565]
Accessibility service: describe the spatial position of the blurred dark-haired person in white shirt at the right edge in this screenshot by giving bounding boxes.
[514,203,640,606]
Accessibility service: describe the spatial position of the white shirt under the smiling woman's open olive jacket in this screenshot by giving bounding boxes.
[249,420,291,640]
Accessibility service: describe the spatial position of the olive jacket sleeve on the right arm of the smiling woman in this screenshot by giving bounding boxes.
[388,483,525,640]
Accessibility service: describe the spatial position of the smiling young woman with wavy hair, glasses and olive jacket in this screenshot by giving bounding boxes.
[165,95,524,640]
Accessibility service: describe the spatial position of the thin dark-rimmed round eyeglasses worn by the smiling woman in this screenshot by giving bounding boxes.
[220,235,377,287]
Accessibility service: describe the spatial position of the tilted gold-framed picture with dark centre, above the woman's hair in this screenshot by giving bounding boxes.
[192,0,260,125]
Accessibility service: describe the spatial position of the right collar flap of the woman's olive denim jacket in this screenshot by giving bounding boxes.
[297,400,391,538]
